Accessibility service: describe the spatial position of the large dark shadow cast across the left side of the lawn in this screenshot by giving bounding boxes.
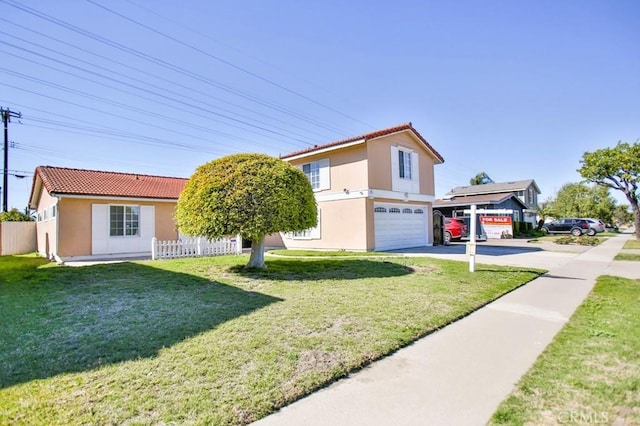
[0,263,281,389]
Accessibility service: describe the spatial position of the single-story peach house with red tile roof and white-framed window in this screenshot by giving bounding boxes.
[29,166,187,261]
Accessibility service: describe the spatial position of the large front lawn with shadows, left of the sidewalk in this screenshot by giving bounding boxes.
[0,256,540,425]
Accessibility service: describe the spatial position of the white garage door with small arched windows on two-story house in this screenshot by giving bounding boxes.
[373,203,427,250]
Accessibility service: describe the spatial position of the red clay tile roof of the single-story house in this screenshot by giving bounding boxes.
[32,166,187,200]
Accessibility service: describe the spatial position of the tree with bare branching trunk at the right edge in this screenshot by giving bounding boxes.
[578,141,640,240]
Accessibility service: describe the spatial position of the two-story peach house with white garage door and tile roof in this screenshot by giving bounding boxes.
[281,123,444,251]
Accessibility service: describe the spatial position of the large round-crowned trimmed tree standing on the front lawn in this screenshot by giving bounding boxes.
[176,154,317,268]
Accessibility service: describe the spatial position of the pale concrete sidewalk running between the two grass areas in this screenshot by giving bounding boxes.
[254,235,640,426]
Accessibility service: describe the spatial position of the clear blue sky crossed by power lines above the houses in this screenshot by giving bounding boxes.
[0,0,640,209]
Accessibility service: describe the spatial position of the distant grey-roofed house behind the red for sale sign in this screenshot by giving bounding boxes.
[433,179,540,226]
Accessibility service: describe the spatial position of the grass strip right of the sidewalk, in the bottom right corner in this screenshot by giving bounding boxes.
[492,276,640,425]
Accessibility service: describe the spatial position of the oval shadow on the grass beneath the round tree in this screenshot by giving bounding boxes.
[229,257,413,281]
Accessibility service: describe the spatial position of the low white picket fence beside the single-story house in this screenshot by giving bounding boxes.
[151,237,242,260]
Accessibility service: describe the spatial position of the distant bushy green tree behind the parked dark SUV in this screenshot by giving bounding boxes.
[548,183,616,222]
